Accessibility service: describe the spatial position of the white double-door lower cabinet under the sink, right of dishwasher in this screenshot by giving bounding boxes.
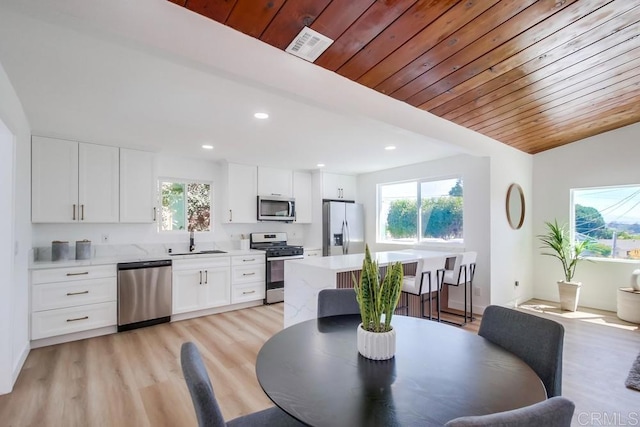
[173,257,231,314]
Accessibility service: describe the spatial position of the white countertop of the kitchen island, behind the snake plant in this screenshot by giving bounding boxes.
[287,249,455,272]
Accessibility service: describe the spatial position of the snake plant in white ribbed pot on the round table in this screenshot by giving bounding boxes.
[352,245,404,360]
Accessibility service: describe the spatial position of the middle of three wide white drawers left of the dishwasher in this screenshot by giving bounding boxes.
[31,277,117,311]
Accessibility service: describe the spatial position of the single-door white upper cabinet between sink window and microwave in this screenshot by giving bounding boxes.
[220,162,258,223]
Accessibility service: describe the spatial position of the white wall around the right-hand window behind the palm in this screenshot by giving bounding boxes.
[532,124,640,311]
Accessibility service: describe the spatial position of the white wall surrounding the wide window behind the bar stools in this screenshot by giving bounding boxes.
[358,155,492,312]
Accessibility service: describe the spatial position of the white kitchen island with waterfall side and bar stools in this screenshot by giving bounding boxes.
[284,249,455,328]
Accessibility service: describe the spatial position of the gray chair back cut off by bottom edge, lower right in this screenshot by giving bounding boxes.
[445,396,575,427]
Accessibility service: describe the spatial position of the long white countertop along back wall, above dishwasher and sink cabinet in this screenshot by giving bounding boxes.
[29,249,264,270]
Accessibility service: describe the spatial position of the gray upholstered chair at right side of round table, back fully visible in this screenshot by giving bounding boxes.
[478,305,564,397]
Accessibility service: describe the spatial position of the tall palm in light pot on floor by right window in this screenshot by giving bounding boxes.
[538,220,589,311]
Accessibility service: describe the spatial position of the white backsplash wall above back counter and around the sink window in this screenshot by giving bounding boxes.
[33,155,306,249]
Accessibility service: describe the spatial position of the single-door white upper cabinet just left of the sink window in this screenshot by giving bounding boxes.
[120,148,157,223]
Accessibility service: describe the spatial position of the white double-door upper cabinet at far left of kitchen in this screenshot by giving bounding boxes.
[31,136,119,223]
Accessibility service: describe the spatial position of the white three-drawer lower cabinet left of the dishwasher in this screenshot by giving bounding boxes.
[31,265,118,340]
